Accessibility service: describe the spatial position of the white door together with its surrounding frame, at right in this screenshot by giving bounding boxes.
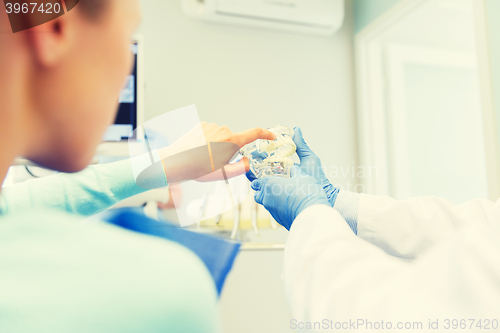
[356,0,499,203]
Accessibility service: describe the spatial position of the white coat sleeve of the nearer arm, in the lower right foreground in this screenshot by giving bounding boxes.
[284,206,500,331]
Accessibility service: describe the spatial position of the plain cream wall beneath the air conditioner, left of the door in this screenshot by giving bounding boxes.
[139,0,357,333]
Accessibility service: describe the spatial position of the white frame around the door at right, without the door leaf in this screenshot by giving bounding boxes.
[354,0,500,200]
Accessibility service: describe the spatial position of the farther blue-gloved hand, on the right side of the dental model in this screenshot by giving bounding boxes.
[293,127,339,207]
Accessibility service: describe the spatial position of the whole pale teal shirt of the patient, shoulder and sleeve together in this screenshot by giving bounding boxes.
[0,157,219,333]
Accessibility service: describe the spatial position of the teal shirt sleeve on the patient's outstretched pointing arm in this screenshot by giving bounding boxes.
[0,156,167,216]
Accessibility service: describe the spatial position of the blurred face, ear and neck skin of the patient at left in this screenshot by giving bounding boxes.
[0,0,140,172]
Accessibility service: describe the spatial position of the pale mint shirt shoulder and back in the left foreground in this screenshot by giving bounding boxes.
[0,212,218,333]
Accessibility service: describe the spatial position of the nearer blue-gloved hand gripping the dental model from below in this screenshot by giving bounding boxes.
[252,166,330,230]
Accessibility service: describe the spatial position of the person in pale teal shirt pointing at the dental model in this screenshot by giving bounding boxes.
[0,0,274,333]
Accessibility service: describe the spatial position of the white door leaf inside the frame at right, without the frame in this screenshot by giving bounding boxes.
[385,45,488,203]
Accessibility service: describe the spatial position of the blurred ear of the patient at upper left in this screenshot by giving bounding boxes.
[26,15,76,67]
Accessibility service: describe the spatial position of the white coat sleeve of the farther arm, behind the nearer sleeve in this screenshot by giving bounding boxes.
[357,195,500,259]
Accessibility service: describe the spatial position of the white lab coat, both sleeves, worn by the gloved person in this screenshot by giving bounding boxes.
[284,195,500,332]
